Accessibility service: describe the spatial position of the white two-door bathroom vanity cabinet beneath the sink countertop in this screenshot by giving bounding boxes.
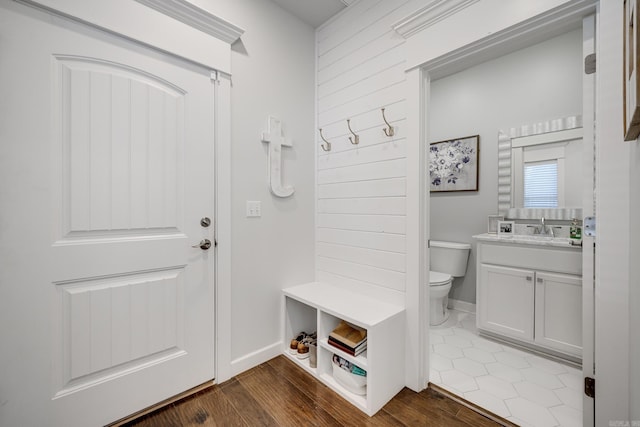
[476,235,582,361]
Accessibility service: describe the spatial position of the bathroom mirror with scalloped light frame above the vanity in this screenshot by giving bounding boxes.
[498,116,583,220]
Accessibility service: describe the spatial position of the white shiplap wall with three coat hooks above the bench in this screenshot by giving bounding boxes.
[316,0,424,304]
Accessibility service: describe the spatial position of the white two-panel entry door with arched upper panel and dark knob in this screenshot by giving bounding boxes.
[0,1,215,426]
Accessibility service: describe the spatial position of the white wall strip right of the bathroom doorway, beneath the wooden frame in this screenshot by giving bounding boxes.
[595,0,640,425]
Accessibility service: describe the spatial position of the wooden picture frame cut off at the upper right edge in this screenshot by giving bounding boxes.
[622,0,640,141]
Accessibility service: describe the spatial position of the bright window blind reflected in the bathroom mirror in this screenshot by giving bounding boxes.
[524,160,558,208]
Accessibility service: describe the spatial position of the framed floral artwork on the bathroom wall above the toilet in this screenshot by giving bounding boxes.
[429,135,480,192]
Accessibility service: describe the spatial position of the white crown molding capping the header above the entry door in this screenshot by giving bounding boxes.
[135,0,244,44]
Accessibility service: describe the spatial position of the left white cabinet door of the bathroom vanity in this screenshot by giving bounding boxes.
[478,264,534,341]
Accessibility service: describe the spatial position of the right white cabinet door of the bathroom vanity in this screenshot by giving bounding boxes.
[535,272,582,357]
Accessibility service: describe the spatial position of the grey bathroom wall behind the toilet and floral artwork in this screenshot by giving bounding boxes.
[428,29,582,303]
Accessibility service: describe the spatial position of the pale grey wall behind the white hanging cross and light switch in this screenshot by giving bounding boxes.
[193,0,315,374]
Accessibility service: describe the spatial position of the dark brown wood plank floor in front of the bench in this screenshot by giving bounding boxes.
[122,356,499,427]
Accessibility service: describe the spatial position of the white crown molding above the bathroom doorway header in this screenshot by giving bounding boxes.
[392,0,479,39]
